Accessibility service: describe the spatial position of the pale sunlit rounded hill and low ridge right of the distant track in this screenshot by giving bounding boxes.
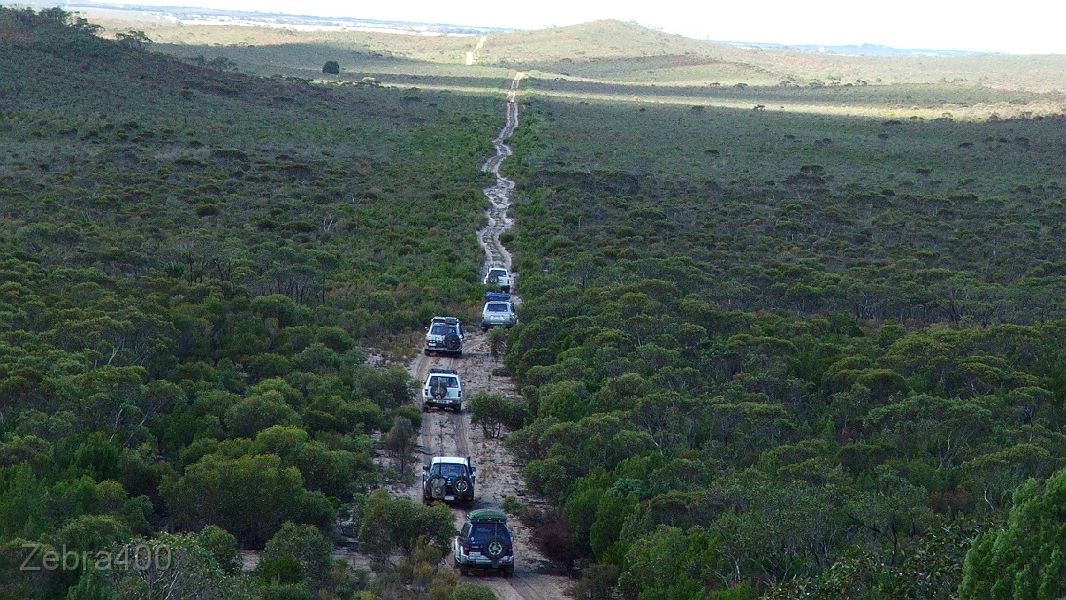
[483,20,1066,92]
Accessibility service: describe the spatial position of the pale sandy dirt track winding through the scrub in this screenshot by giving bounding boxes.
[406,74,569,600]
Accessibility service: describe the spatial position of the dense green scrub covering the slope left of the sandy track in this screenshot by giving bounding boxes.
[0,10,498,598]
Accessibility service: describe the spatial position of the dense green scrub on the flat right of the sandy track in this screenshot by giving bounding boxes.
[506,88,1066,599]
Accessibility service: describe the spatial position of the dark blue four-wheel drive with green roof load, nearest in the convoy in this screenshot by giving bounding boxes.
[452,508,515,577]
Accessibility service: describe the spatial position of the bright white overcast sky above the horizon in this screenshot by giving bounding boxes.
[85,0,1066,53]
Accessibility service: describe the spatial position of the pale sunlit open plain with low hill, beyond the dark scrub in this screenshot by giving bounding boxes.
[96,14,1066,111]
